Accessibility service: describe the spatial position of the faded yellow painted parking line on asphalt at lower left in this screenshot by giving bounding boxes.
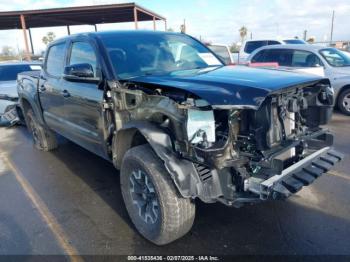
[0,153,83,262]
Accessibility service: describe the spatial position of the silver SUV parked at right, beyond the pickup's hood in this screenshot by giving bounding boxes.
[248,44,350,115]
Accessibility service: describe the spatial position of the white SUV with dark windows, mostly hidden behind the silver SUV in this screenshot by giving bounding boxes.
[238,39,307,63]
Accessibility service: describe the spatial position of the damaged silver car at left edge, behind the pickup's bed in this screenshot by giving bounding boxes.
[0,62,41,126]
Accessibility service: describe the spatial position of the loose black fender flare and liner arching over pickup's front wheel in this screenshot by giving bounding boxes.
[113,121,222,202]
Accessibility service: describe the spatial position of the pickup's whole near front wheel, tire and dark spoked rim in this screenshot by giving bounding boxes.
[120,145,195,245]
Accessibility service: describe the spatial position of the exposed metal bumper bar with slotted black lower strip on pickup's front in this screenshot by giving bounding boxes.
[245,147,343,200]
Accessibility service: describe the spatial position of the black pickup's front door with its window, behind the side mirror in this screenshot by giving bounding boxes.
[62,40,105,157]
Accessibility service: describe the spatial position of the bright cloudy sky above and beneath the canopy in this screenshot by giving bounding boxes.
[0,0,350,53]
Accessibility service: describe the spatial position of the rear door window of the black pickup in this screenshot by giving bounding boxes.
[46,43,66,77]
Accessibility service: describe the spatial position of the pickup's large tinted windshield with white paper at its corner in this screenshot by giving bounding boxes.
[102,33,223,79]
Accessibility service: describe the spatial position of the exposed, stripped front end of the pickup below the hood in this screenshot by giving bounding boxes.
[104,77,334,206]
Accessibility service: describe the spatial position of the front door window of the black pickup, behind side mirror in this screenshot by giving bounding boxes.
[69,42,97,76]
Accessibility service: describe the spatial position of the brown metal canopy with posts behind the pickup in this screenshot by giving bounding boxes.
[0,3,167,59]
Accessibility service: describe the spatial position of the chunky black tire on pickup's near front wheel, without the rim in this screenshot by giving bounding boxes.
[120,145,195,245]
